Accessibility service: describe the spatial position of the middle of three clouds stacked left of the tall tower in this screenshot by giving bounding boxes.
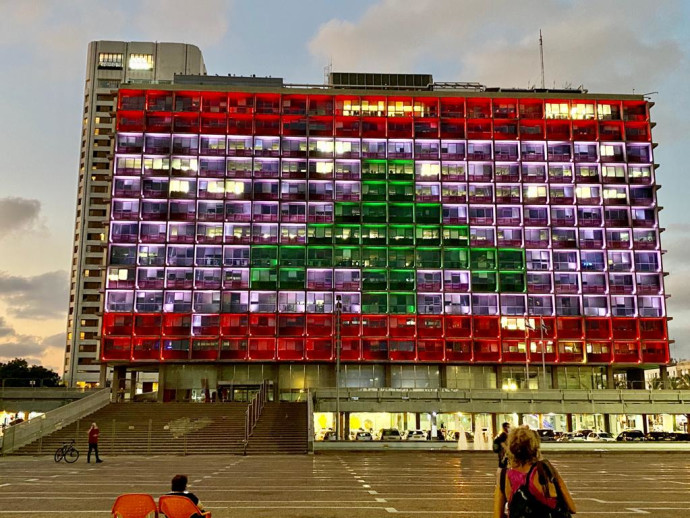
[0,270,69,318]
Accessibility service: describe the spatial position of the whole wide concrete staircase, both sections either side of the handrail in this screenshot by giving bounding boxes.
[14,402,307,457]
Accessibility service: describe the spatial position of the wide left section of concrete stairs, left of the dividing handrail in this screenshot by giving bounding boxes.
[16,403,247,457]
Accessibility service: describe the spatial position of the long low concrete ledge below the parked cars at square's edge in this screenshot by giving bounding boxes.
[314,441,690,455]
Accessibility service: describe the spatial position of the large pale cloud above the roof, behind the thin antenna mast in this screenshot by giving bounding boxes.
[309,0,683,91]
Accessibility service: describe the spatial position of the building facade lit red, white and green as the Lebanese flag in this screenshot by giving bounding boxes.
[101,74,669,397]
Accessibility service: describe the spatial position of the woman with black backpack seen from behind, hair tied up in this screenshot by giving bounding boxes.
[494,426,576,518]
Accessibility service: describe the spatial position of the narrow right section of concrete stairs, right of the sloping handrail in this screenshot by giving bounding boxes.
[247,402,308,455]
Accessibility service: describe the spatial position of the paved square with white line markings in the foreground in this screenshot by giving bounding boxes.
[0,452,690,518]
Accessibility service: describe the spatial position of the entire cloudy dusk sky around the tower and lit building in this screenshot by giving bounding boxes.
[0,0,690,369]
